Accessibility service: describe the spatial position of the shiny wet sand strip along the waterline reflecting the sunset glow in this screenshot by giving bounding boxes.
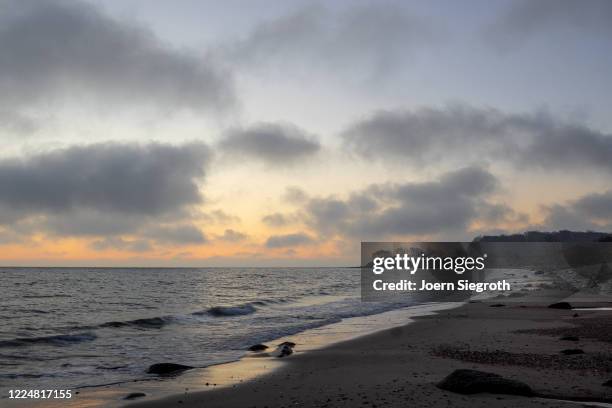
[2,302,463,408]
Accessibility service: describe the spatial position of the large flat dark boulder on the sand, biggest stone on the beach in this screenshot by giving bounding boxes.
[438,369,534,396]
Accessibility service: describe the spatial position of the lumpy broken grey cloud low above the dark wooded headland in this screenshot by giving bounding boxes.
[303,167,516,240]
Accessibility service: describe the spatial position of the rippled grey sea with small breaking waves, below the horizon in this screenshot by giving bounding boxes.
[0,268,414,389]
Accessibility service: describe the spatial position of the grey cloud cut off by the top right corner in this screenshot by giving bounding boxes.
[486,0,612,49]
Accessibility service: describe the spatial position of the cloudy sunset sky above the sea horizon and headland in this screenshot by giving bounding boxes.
[0,0,612,266]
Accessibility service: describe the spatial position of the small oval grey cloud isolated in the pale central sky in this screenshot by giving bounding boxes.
[219,123,321,165]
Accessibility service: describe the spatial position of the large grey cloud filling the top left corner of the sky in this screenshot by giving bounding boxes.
[0,0,235,125]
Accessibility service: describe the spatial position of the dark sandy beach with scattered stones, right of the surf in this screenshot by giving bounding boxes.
[128,299,612,408]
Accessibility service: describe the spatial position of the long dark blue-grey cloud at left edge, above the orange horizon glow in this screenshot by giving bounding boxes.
[0,143,210,215]
